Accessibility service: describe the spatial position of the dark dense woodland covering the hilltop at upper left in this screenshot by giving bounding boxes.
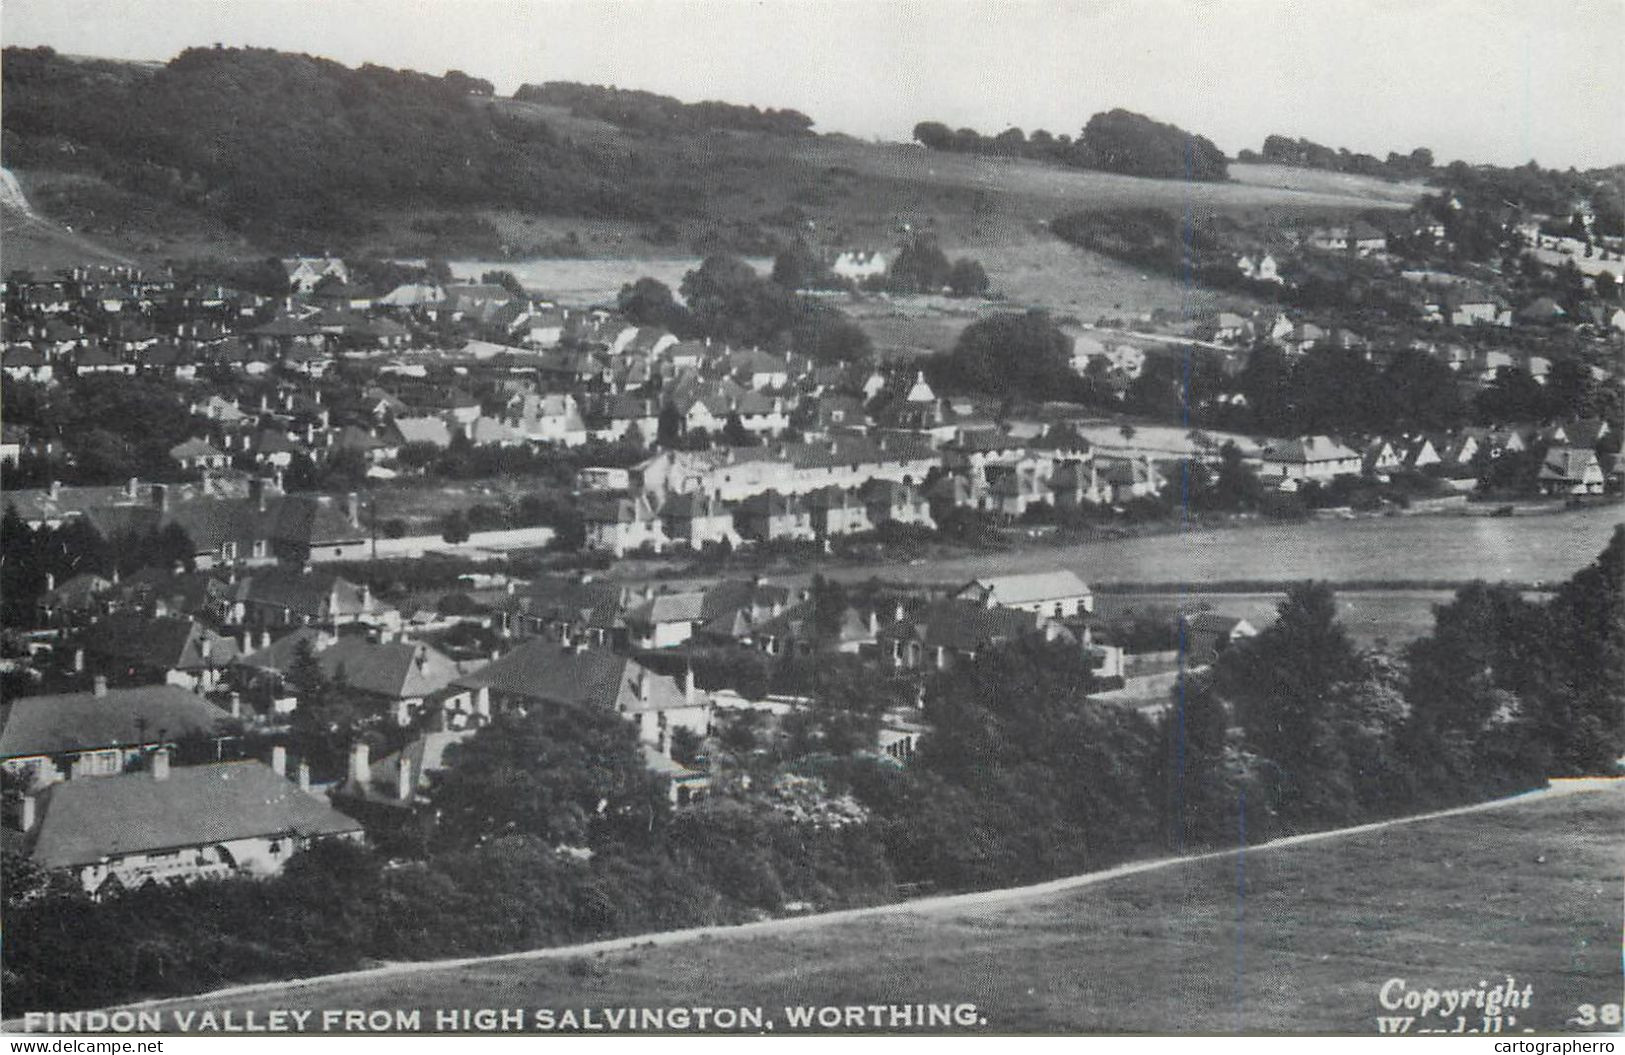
[0,47,700,244]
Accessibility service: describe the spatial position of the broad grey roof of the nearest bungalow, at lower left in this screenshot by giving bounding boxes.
[33,761,361,868]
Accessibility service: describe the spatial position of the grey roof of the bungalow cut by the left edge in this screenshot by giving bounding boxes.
[0,684,228,759]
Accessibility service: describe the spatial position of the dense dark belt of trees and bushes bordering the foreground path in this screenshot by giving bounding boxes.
[3,530,1625,1011]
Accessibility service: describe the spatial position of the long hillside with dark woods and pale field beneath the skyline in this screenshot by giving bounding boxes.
[3,49,1417,276]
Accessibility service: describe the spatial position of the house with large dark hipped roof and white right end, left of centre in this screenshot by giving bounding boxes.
[445,639,712,753]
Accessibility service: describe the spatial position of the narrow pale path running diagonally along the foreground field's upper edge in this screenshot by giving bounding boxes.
[38,777,1625,1032]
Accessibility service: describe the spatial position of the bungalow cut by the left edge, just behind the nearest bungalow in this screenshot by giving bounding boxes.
[0,675,229,787]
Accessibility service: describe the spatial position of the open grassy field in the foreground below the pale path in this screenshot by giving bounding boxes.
[88,784,1625,1034]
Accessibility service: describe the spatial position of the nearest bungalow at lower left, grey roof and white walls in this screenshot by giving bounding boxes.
[23,748,364,897]
